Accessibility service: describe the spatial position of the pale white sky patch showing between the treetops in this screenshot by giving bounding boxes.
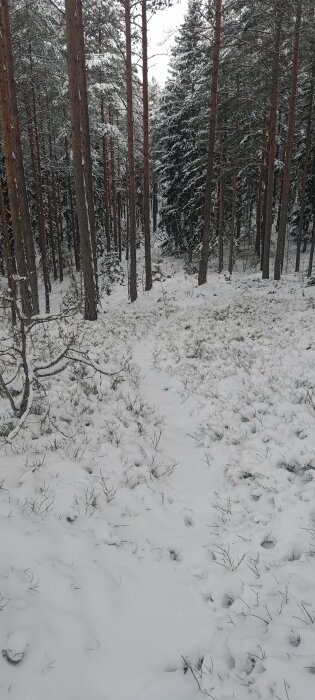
[148,0,188,85]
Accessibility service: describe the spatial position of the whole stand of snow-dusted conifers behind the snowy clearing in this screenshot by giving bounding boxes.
[0,0,315,320]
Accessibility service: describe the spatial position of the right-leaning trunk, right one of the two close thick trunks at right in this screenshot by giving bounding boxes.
[274,0,302,280]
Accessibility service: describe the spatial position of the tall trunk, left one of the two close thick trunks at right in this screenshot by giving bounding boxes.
[262,5,283,279]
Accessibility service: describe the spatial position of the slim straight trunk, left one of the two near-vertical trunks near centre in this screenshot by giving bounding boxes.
[125,0,137,301]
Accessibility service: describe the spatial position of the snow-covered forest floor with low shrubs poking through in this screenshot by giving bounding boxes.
[0,260,315,700]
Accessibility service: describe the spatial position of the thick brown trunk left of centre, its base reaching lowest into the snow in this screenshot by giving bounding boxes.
[65,0,97,321]
